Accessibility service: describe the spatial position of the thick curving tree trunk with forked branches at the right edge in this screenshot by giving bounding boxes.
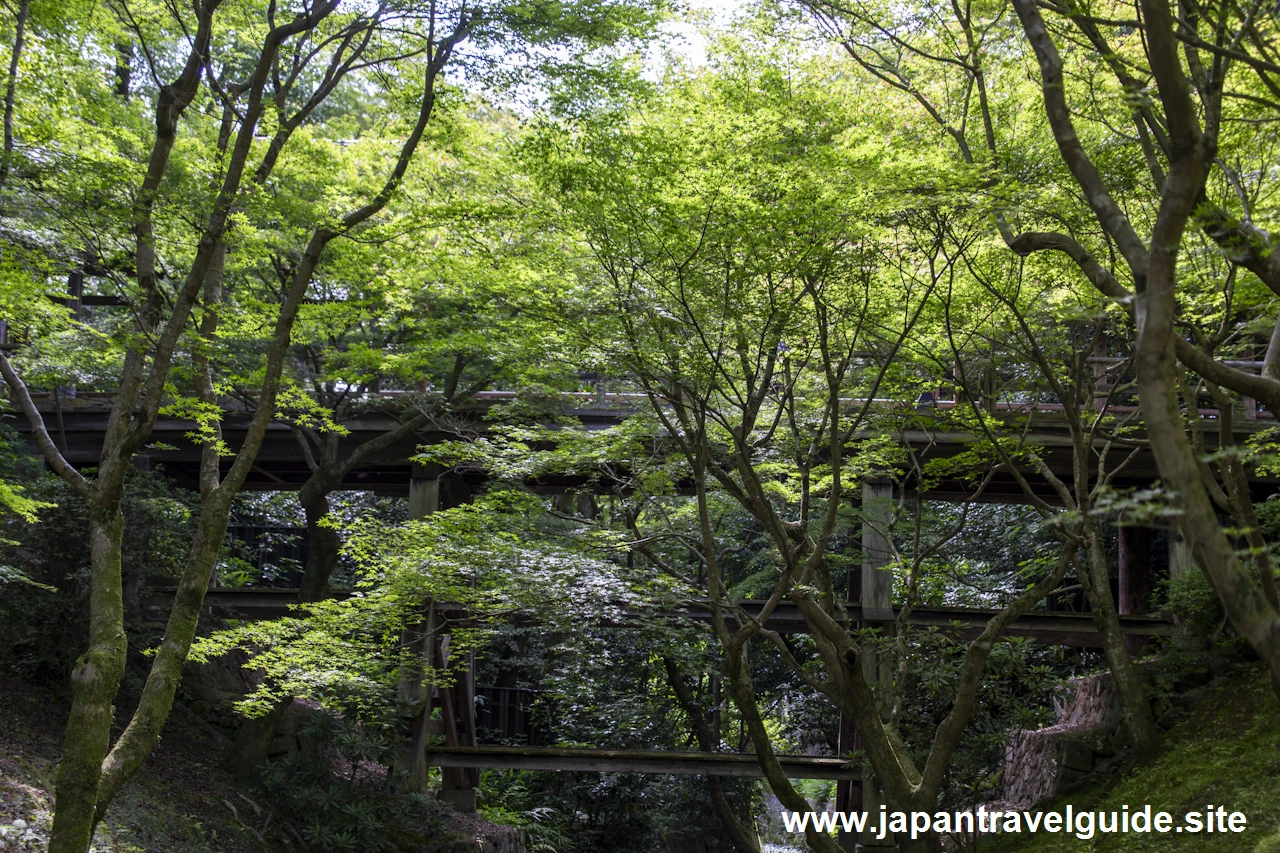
[1010,0,1280,694]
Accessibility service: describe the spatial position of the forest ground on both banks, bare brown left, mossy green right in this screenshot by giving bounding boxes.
[12,672,1280,853]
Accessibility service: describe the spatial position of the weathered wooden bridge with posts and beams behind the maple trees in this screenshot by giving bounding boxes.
[18,392,1208,809]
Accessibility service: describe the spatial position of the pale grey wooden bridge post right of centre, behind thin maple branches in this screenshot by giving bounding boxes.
[859,483,893,847]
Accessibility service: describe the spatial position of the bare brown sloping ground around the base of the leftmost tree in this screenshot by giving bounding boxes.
[0,681,262,853]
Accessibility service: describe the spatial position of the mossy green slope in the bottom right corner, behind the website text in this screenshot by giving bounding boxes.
[979,674,1280,853]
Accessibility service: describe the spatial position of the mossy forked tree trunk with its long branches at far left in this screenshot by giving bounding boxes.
[12,6,458,853]
